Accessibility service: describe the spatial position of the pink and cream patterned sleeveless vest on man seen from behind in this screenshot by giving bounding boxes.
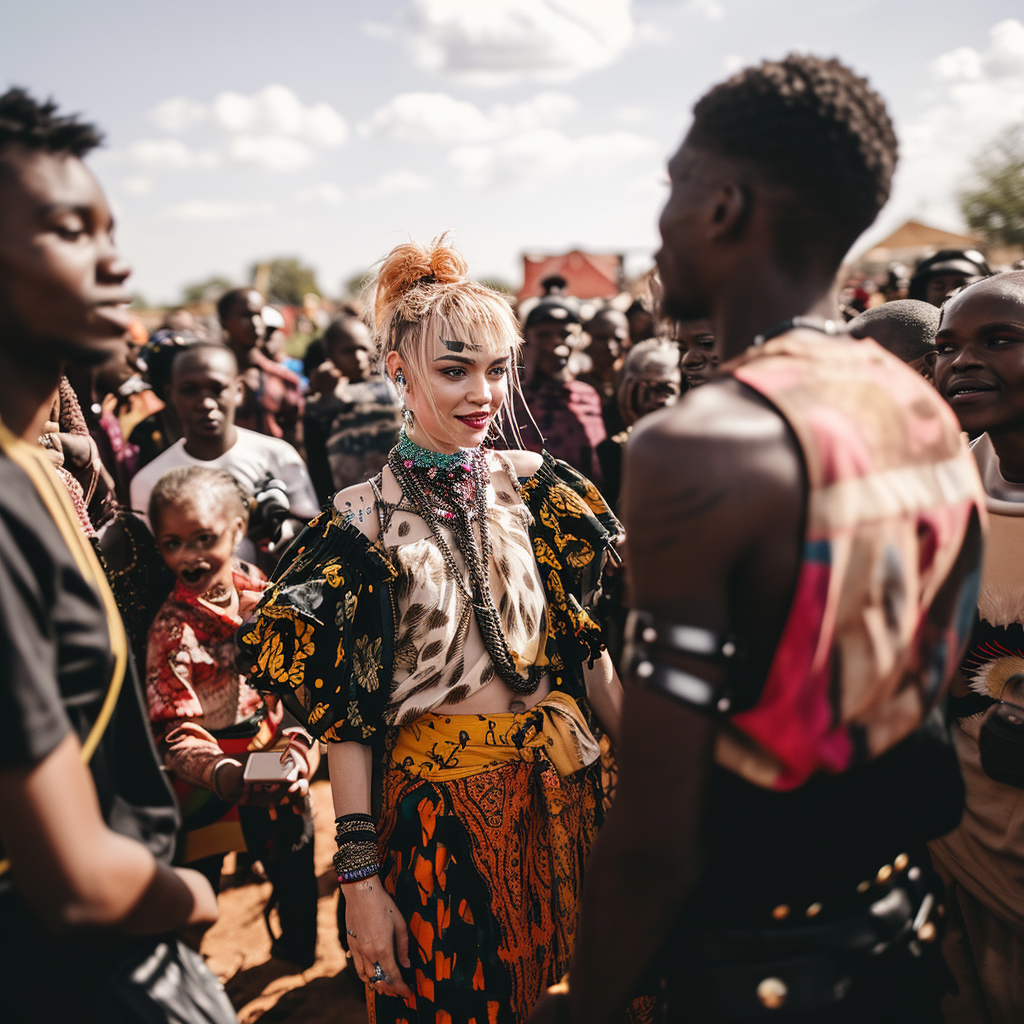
[716,330,985,790]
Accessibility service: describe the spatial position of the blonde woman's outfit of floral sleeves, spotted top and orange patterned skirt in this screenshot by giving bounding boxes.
[242,456,620,1024]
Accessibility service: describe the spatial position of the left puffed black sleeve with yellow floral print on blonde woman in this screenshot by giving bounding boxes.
[239,508,396,744]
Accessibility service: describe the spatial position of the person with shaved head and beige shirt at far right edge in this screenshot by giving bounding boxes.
[933,272,1024,1024]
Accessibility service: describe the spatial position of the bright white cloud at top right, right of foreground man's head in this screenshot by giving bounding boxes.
[880,18,1024,229]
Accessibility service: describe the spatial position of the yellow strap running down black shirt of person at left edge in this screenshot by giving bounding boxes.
[0,411,128,874]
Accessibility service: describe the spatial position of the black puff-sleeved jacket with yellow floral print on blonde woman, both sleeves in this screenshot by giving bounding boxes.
[239,453,622,744]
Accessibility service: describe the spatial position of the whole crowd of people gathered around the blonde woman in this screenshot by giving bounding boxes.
[0,46,1024,1024]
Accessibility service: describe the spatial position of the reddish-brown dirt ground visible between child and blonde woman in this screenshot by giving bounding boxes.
[202,780,367,1024]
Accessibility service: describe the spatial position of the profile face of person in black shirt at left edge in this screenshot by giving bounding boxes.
[0,145,131,366]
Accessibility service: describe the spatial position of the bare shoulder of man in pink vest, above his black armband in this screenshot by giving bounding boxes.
[620,380,806,614]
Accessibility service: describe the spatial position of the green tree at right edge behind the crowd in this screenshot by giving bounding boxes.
[959,124,1024,246]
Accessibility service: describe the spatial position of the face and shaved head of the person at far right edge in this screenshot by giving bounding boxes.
[934,273,1024,431]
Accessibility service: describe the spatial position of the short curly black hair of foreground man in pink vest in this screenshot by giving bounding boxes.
[688,53,898,272]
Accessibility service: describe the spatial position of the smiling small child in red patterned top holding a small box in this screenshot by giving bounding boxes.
[146,466,319,967]
